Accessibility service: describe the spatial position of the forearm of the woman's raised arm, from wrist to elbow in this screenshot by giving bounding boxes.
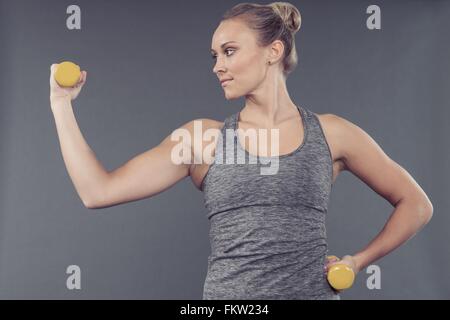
[50,98,108,206]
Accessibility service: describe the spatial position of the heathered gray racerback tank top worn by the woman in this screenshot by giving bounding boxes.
[201,106,340,300]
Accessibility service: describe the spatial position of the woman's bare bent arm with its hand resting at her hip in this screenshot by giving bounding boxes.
[326,114,433,273]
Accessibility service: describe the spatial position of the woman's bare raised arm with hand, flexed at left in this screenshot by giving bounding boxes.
[50,65,195,209]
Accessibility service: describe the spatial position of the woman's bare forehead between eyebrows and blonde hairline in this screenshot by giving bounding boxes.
[211,20,254,50]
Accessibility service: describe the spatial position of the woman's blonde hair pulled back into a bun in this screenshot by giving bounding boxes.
[222,2,301,77]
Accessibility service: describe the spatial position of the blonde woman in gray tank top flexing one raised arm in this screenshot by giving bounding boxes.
[50,2,433,299]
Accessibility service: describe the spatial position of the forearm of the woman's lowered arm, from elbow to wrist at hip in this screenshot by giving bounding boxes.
[353,200,432,270]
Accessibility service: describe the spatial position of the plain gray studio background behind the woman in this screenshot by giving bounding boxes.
[0,0,450,299]
